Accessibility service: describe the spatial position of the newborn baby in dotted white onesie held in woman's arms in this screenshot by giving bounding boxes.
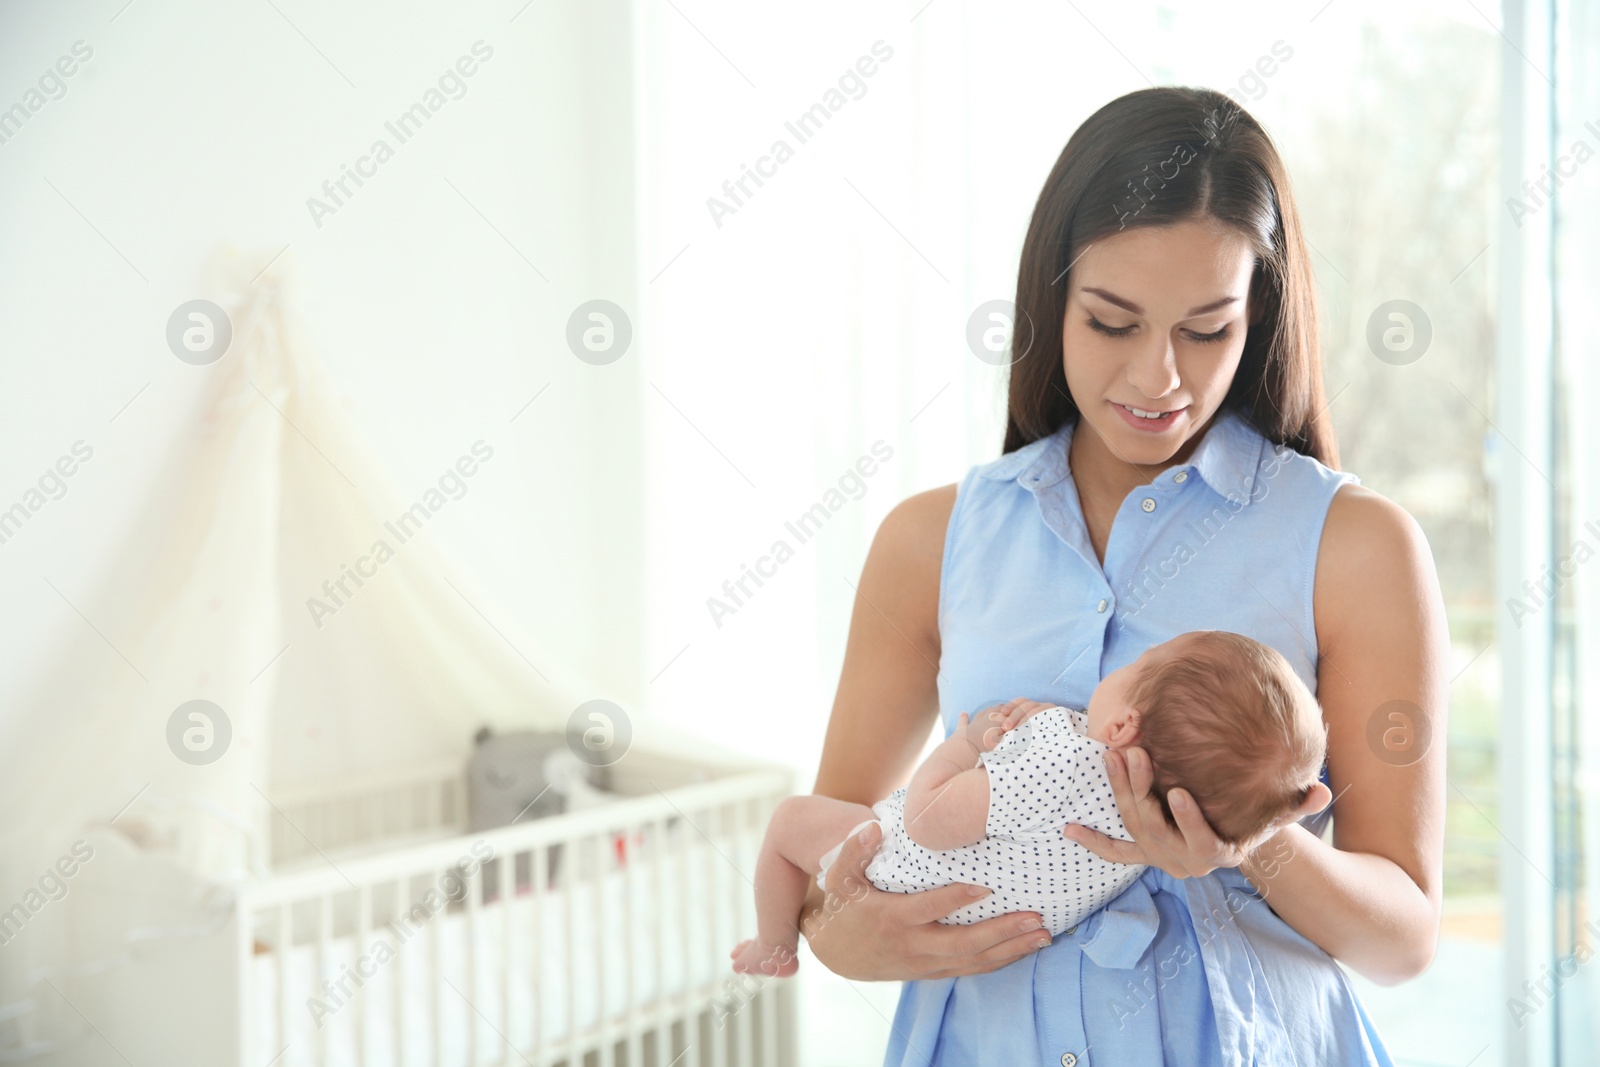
[728,630,1326,977]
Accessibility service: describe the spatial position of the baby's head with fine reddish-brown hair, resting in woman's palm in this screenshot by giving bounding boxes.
[1088,630,1326,845]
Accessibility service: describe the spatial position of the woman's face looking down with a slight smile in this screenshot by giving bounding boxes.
[1061,219,1256,467]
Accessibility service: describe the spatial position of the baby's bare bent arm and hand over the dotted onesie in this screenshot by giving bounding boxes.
[906,697,1050,851]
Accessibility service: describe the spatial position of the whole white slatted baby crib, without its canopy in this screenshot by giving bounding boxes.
[40,750,797,1067]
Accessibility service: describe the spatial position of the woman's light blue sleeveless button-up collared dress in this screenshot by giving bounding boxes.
[883,413,1392,1067]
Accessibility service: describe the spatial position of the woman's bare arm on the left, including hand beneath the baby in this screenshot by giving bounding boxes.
[800,485,1048,981]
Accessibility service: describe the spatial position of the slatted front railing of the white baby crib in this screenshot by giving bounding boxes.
[237,764,795,1067]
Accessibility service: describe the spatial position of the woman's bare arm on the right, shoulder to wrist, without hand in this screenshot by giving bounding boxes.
[1243,486,1450,985]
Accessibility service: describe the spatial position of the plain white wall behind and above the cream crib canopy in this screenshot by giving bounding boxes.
[0,0,643,726]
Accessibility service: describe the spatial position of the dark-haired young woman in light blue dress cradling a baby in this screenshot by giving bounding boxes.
[800,88,1448,1067]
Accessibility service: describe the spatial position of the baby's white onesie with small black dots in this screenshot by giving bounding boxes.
[818,707,1144,934]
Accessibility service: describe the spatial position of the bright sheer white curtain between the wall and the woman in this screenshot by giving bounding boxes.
[637,0,1158,789]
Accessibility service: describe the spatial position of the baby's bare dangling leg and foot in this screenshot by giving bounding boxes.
[728,795,875,977]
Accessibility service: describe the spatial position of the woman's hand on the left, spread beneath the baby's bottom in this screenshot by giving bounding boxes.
[800,824,1050,981]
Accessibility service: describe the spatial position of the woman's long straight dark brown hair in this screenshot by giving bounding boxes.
[1003,86,1339,467]
